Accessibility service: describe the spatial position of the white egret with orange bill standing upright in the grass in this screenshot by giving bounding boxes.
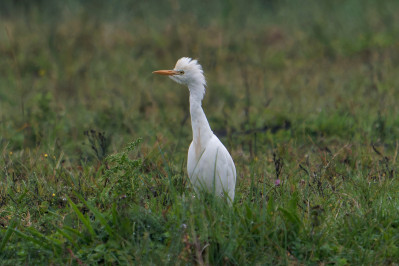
[153,57,237,204]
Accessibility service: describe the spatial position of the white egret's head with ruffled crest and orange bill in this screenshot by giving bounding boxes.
[152,57,206,89]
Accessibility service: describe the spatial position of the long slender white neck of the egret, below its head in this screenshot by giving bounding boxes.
[189,85,213,149]
